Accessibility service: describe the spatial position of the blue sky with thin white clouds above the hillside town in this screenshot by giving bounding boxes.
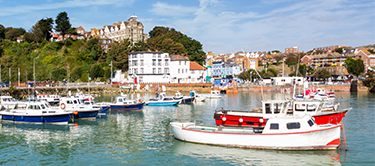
[0,0,375,54]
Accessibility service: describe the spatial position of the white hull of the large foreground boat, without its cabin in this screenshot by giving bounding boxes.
[171,122,341,150]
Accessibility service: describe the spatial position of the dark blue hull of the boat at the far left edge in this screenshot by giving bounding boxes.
[0,114,71,124]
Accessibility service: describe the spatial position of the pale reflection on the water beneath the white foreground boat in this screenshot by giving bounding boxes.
[171,140,341,165]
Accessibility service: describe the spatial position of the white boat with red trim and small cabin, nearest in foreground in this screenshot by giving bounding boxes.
[170,115,341,150]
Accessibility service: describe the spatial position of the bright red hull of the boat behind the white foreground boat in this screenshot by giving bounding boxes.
[214,109,348,127]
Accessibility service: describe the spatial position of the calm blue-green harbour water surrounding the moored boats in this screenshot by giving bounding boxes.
[0,92,375,165]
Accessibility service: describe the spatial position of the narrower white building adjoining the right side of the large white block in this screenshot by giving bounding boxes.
[170,55,191,83]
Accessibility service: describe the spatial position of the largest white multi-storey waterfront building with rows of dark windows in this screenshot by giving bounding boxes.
[129,51,171,83]
